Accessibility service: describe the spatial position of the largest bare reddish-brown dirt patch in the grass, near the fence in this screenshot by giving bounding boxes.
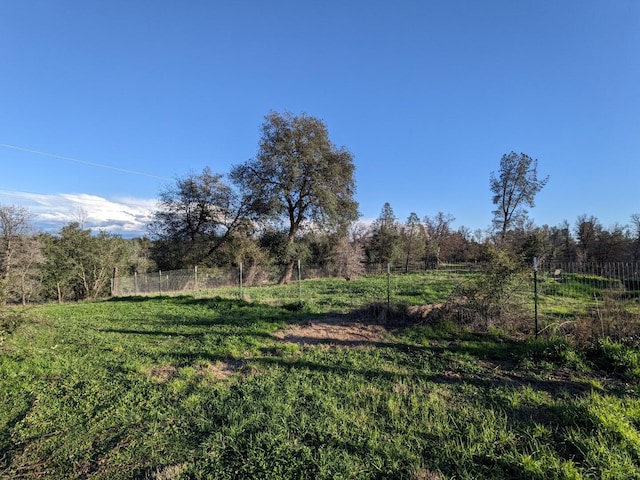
[273,317,387,347]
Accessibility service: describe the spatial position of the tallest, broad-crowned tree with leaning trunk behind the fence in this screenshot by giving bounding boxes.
[231,112,358,283]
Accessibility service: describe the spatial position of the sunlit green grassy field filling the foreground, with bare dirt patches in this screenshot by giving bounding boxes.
[0,280,640,480]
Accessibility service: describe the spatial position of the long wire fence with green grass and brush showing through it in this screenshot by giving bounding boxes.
[112,263,640,339]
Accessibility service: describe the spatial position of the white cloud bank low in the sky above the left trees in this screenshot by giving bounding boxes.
[0,190,157,237]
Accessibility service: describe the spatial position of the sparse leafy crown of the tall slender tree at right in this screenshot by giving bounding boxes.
[490,152,549,242]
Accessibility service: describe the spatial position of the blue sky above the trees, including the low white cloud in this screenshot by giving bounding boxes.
[0,0,640,235]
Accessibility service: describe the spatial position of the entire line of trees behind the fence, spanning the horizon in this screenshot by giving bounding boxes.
[0,112,640,304]
